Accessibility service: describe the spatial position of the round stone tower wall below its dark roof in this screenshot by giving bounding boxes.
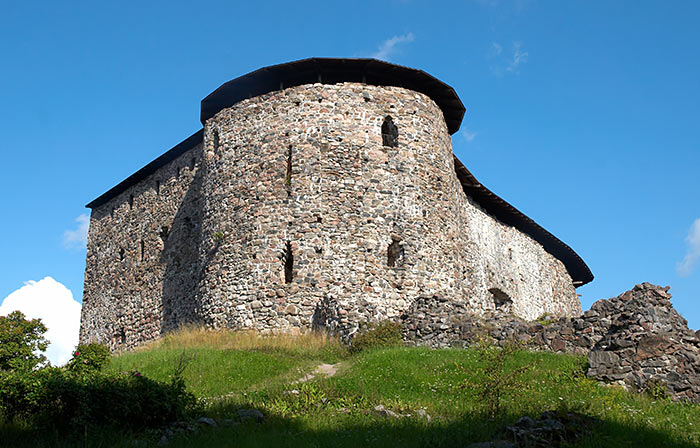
[194,63,474,332]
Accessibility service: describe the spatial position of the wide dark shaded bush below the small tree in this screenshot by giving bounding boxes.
[0,367,196,433]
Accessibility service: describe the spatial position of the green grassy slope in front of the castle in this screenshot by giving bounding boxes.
[0,330,700,448]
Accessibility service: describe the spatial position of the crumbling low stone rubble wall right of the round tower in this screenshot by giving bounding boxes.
[401,283,700,403]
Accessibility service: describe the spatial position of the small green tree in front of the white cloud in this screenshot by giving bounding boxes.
[0,311,49,371]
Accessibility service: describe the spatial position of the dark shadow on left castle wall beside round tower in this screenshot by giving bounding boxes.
[160,161,204,334]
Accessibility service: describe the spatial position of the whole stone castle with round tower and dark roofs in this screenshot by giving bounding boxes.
[80,58,593,349]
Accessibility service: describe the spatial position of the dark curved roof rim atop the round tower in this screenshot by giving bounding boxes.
[200,58,465,134]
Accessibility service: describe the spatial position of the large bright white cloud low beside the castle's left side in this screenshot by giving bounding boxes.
[0,277,81,365]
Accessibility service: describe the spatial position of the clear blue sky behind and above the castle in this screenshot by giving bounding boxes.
[0,0,700,358]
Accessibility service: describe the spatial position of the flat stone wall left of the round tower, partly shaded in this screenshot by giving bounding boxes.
[80,144,203,349]
